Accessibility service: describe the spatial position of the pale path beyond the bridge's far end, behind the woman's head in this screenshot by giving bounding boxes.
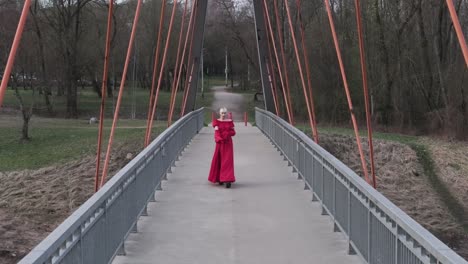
[211,86,247,121]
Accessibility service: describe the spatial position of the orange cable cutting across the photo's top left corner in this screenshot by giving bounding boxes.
[0,0,31,107]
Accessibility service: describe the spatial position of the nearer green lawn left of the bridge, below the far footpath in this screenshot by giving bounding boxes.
[0,117,165,172]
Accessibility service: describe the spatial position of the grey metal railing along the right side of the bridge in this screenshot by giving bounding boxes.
[255,108,468,264]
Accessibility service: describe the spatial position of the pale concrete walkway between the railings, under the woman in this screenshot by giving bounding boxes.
[113,123,361,264]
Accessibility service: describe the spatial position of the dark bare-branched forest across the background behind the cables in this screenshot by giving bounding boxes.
[0,0,468,139]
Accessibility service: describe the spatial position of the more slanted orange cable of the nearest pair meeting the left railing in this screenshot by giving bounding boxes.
[100,0,143,187]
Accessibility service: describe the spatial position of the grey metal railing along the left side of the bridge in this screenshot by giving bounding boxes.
[19,109,204,264]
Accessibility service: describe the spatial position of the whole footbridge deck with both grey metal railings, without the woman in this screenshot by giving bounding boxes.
[20,109,467,264]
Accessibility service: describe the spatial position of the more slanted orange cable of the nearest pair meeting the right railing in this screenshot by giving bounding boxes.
[324,0,370,183]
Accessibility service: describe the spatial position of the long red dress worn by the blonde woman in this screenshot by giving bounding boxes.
[208,119,236,183]
